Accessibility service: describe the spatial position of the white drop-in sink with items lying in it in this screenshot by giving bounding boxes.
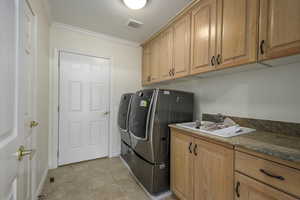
[176,122,255,138]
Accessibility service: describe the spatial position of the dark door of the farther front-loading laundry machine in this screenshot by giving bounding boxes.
[118,93,133,145]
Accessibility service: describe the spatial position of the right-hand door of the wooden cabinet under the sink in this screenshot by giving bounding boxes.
[194,139,234,200]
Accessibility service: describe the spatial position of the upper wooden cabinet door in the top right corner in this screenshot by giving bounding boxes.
[259,0,300,60]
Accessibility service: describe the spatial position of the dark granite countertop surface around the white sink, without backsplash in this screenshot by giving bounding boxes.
[169,124,300,164]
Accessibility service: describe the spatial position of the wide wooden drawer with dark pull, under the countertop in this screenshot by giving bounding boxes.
[235,151,300,197]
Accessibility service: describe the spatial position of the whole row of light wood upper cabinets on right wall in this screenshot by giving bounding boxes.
[143,0,300,85]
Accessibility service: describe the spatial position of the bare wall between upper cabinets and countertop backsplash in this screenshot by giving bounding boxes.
[152,63,300,123]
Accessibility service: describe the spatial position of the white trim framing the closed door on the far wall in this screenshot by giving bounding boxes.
[48,48,112,169]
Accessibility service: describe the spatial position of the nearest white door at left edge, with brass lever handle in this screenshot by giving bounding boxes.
[0,0,30,200]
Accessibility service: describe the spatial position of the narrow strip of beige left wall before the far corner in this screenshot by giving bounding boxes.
[29,0,50,195]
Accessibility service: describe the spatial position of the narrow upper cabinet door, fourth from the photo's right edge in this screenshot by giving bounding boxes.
[173,15,191,78]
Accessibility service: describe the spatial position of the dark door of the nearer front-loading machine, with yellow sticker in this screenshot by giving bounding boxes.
[128,90,155,141]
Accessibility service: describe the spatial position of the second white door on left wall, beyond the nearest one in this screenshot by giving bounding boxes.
[18,0,37,200]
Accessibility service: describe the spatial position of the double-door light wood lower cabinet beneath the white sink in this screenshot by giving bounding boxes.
[171,129,234,200]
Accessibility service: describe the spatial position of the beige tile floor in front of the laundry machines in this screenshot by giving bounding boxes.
[42,158,176,200]
